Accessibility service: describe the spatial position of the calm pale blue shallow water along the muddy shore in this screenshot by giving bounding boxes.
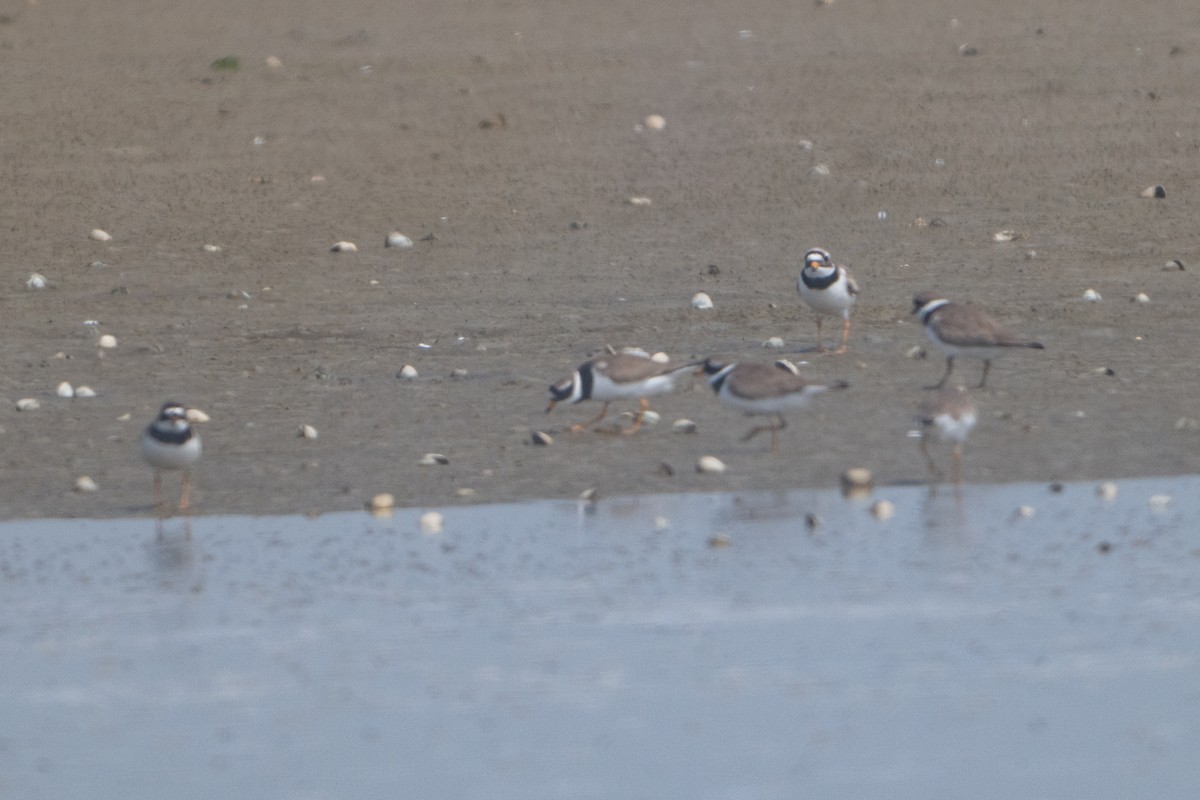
[0,477,1200,800]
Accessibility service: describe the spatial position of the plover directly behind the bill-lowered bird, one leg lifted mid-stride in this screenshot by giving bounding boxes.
[701,357,850,452]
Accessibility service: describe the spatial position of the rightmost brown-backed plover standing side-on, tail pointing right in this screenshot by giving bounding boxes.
[912,291,1045,389]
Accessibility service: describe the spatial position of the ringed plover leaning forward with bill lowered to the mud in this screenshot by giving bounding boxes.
[546,353,696,434]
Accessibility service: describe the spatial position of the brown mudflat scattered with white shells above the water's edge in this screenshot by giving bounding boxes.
[0,0,1200,518]
